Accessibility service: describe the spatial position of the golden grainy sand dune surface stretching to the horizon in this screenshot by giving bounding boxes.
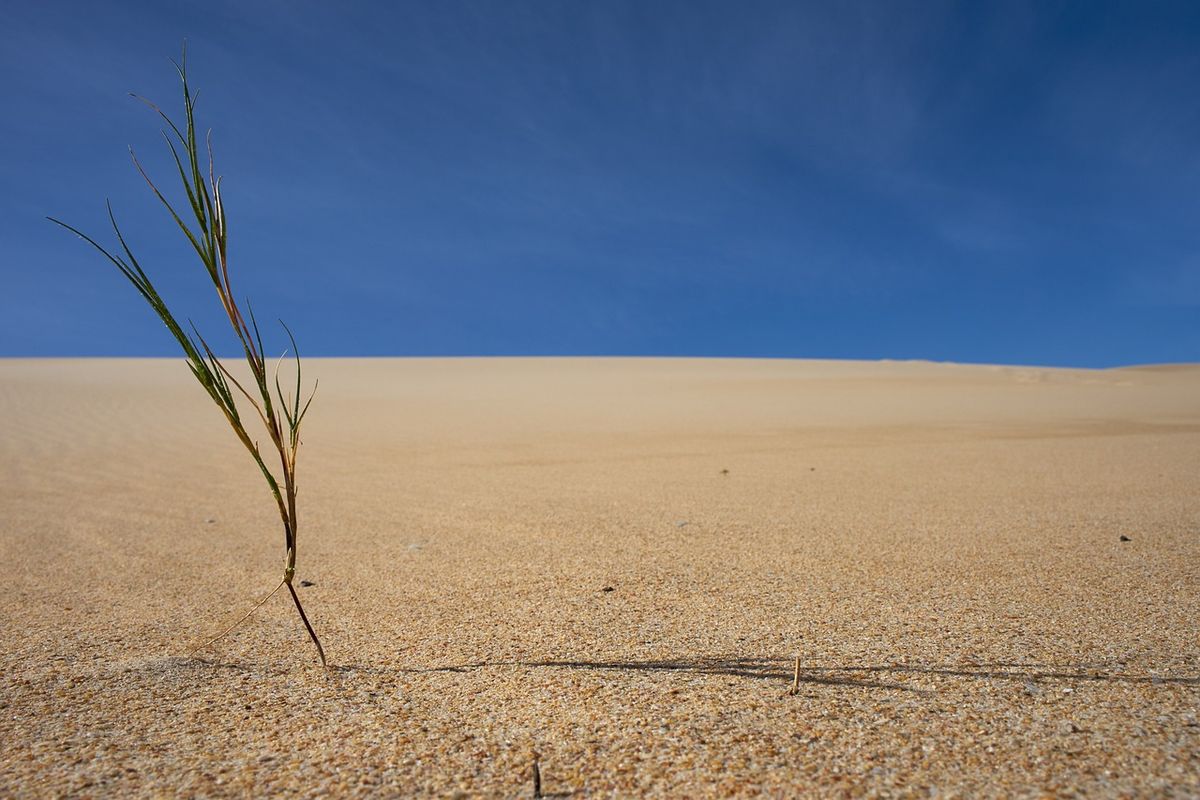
[0,359,1200,798]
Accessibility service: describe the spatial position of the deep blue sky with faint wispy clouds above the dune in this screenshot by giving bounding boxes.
[0,0,1200,366]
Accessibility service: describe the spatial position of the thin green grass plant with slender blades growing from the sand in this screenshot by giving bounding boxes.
[49,47,328,666]
